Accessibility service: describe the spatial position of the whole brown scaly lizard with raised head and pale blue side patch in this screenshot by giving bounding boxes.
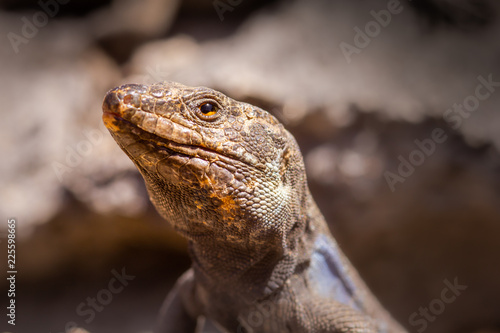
[103,82,405,333]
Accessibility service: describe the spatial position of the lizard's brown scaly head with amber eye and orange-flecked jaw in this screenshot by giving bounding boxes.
[103,82,307,246]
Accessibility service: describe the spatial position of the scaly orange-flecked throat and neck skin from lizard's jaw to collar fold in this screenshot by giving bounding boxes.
[143,157,312,301]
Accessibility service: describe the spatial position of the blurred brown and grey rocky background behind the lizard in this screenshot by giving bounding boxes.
[0,0,500,333]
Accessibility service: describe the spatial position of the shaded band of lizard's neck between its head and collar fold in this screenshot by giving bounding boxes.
[189,192,320,300]
